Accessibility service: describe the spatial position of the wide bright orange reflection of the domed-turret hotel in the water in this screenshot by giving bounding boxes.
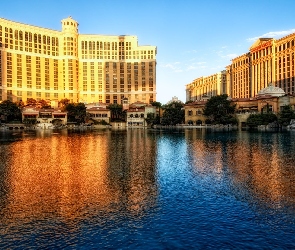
[0,130,157,229]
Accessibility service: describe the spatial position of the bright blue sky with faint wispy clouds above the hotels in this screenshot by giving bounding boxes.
[0,0,295,104]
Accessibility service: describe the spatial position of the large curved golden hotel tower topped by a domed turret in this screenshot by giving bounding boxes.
[0,17,157,103]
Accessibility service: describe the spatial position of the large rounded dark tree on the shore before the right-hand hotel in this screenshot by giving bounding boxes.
[203,94,237,124]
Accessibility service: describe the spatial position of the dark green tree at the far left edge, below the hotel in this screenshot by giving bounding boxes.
[0,100,22,122]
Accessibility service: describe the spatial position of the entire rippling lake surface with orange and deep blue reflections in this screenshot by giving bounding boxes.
[0,129,295,249]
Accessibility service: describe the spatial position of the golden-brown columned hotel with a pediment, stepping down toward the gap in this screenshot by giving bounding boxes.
[186,33,295,101]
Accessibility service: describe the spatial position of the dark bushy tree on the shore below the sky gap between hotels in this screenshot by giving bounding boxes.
[161,102,184,125]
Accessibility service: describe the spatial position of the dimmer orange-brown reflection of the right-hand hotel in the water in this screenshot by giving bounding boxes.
[186,130,295,208]
